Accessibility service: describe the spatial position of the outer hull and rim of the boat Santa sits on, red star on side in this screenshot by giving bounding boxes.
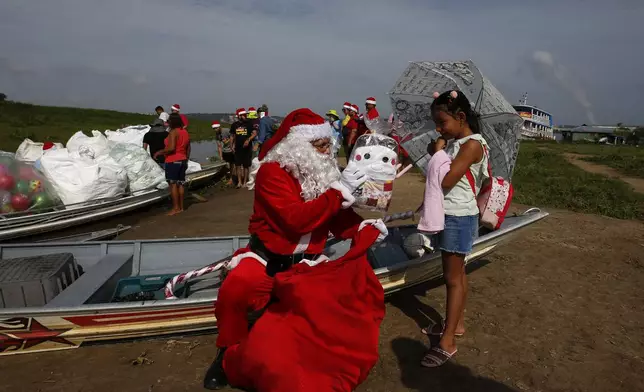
[0,210,548,355]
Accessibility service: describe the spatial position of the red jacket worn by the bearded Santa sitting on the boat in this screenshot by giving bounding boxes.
[248,162,362,255]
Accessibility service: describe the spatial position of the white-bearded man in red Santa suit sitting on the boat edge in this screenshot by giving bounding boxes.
[204,109,387,389]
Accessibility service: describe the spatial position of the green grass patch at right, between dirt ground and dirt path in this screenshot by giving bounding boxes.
[512,143,644,219]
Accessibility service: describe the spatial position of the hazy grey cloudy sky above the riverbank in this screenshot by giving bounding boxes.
[0,0,644,124]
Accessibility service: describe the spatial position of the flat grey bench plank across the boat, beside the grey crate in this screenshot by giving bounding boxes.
[45,254,133,307]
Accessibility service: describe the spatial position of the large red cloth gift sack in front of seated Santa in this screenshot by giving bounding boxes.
[224,226,385,392]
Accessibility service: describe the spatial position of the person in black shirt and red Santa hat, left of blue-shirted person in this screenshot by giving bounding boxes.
[230,108,257,189]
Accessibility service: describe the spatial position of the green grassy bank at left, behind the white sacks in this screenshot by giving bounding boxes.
[0,101,219,152]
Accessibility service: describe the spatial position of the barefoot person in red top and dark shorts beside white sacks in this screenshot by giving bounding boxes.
[154,113,190,215]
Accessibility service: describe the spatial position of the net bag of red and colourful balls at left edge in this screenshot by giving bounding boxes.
[0,153,62,215]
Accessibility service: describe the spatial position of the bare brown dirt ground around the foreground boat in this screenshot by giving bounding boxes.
[0,169,644,392]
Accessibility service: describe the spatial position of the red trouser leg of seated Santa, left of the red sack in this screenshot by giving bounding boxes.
[215,257,273,348]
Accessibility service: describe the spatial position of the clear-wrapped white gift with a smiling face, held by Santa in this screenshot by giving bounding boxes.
[347,133,400,212]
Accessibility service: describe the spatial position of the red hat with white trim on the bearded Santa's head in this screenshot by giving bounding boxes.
[258,108,333,161]
